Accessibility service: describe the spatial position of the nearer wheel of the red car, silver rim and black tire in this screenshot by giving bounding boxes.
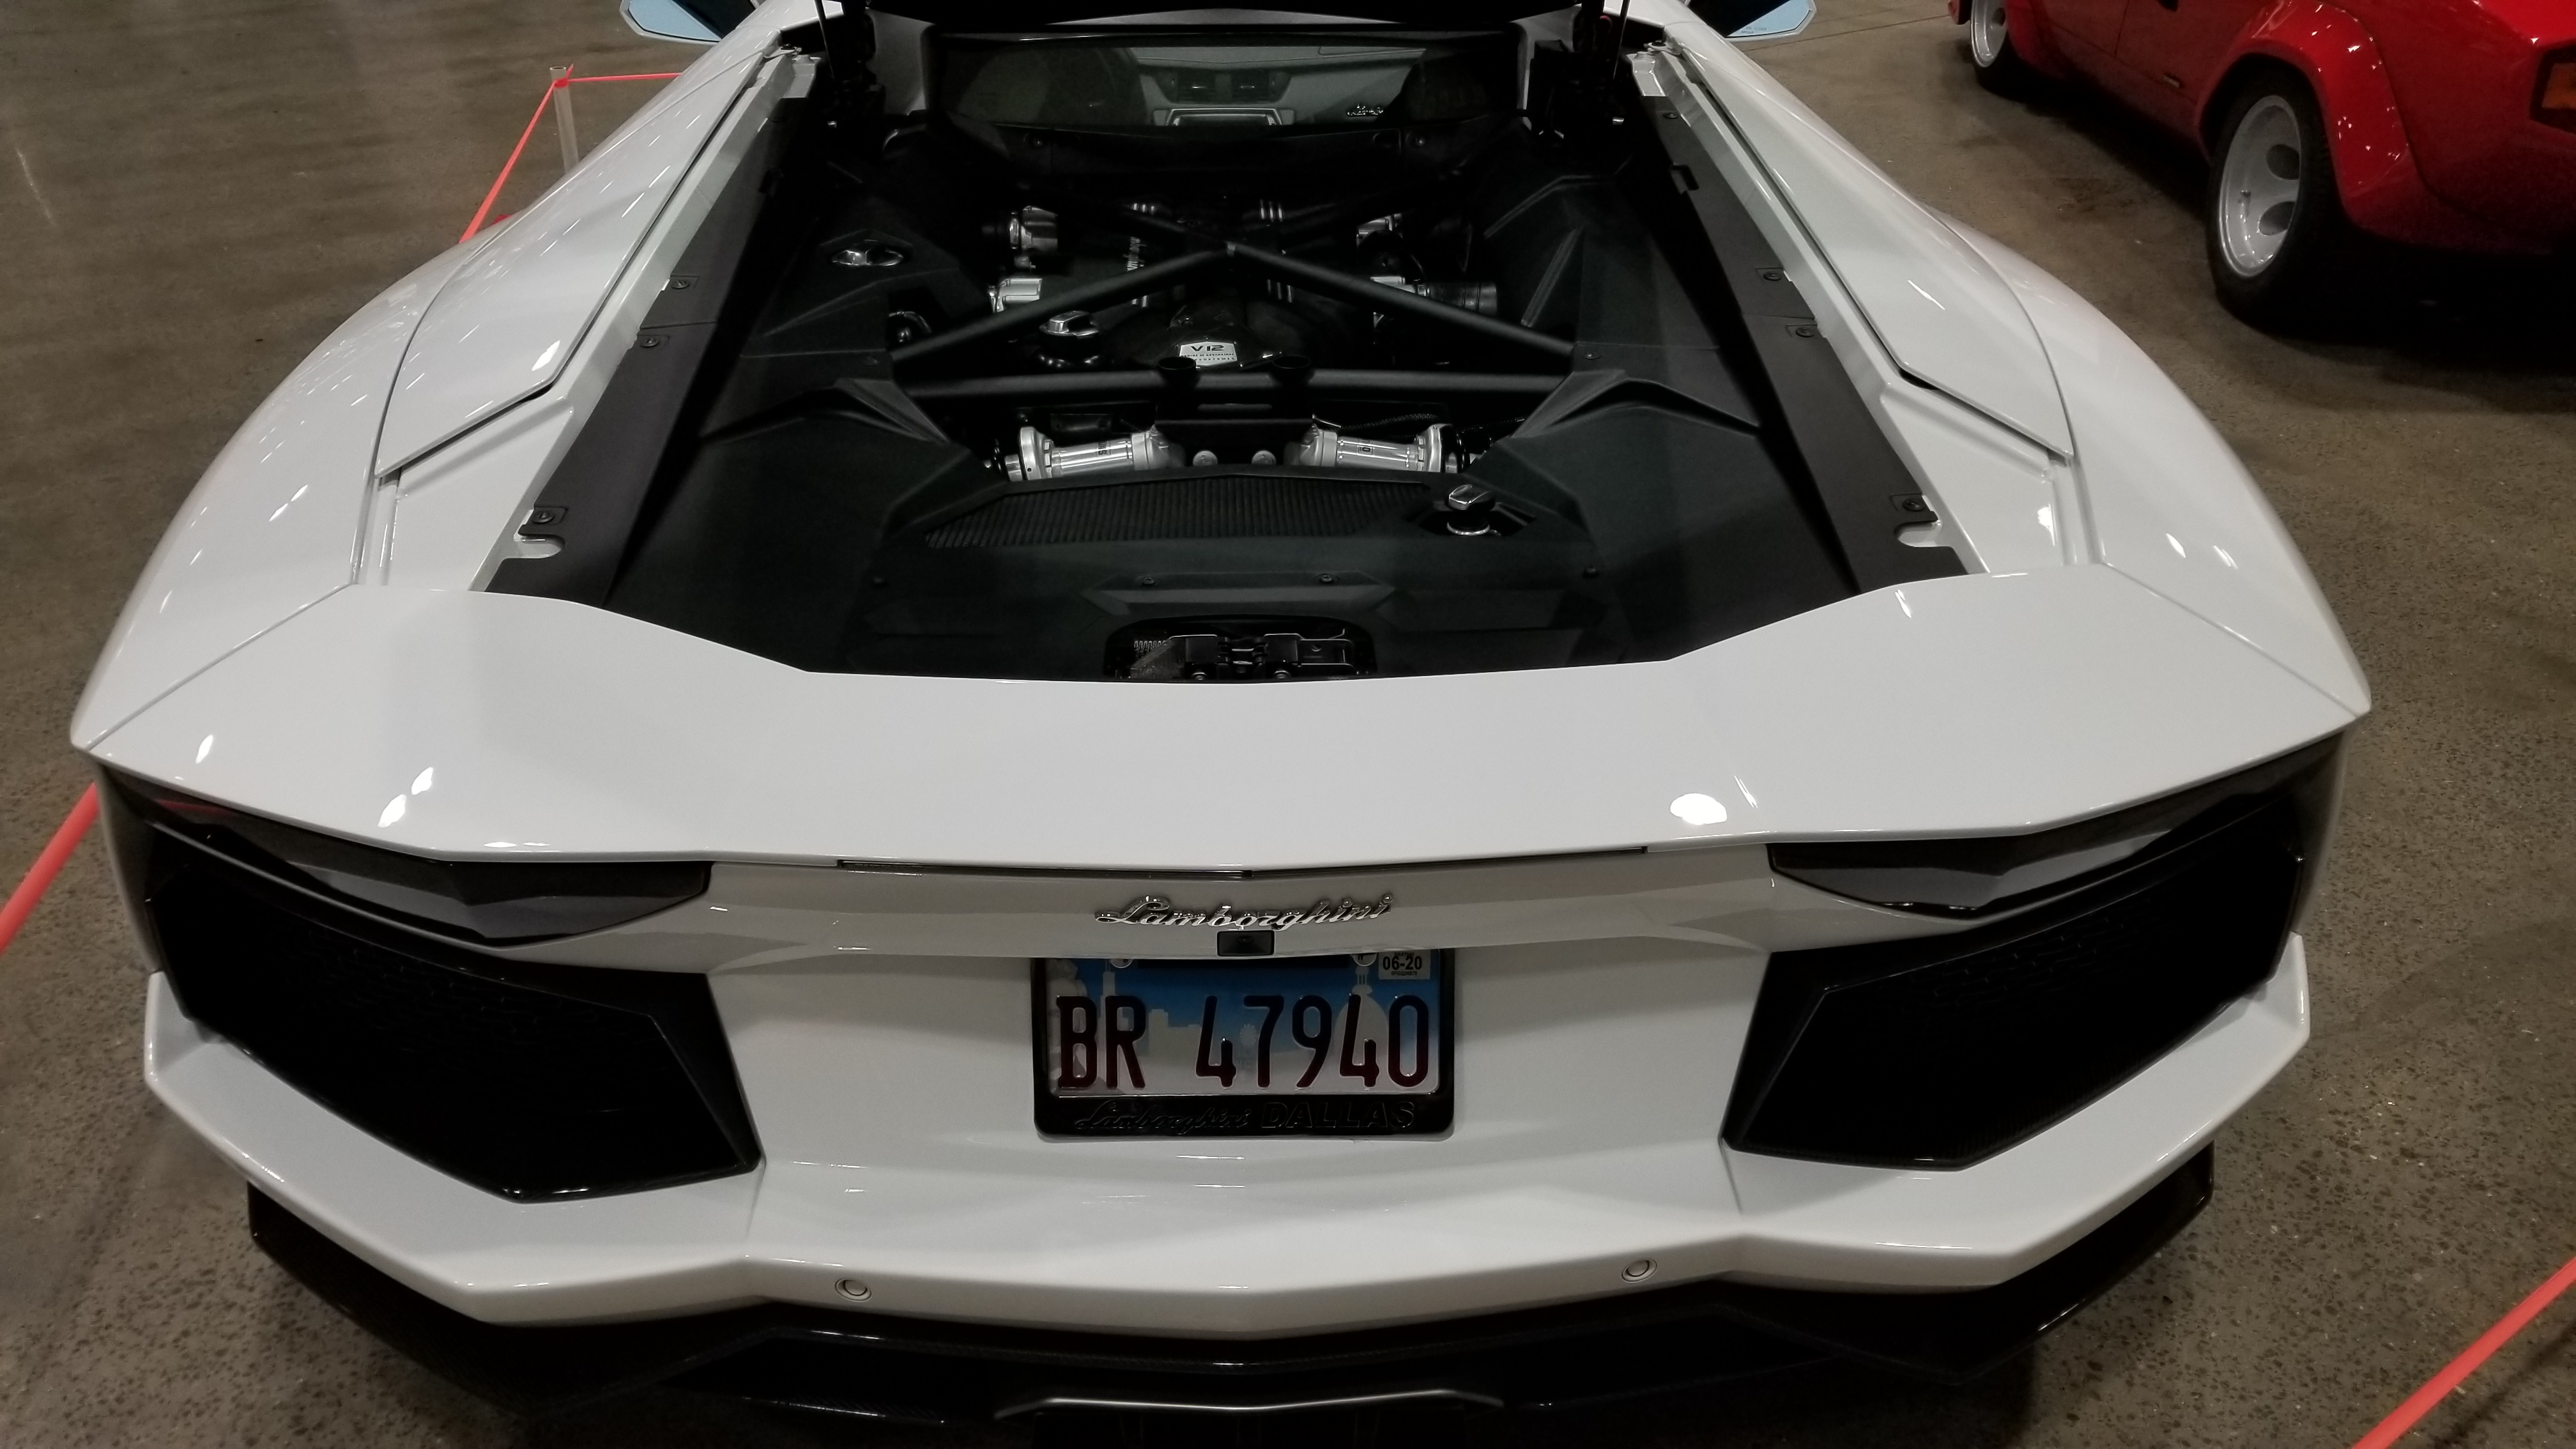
[2202,72,2354,328]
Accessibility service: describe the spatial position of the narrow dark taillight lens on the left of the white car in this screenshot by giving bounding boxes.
[105,771,709,946]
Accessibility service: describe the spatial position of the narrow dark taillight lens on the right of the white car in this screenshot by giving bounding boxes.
[1770,737,2342,918]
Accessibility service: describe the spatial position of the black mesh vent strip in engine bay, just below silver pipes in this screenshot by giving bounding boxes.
[928,475,1422,549]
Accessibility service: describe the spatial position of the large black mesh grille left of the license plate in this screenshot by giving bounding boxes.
[147,838,757,1199]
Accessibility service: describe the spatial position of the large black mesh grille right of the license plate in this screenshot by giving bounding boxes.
[1726,797,2303,1168]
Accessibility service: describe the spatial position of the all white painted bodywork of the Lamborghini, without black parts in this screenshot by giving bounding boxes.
[91,0,2367,1335]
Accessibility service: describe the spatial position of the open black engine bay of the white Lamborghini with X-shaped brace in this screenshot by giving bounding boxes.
[494,13,1958,683]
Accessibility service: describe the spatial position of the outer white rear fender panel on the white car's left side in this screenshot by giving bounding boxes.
[72,245,474,747]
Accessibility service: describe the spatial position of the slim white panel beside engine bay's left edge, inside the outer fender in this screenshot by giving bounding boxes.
[376,48,765,472]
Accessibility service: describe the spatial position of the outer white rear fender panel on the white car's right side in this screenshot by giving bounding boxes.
[1952,222,2370,714]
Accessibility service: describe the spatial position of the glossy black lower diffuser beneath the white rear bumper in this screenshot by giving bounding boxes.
[250,1147,2210,1421]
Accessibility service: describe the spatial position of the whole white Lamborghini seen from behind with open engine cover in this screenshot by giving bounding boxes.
[75,0,2367,1418]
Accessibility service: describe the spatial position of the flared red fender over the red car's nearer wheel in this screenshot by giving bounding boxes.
[2195,0,2540,250]
